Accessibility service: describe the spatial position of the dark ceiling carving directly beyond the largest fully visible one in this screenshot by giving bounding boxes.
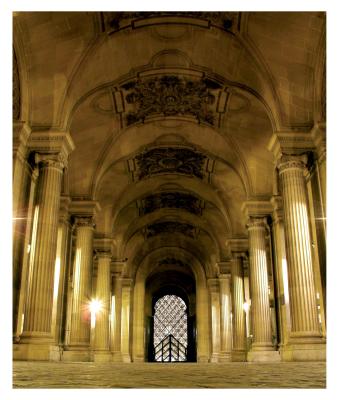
[135,147,207,179]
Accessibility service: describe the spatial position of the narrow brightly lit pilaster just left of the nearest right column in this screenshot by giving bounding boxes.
[271,196,291,350]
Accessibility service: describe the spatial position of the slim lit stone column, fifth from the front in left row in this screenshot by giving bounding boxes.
[121,278,133,362]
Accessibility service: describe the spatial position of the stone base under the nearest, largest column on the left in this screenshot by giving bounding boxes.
[13,343,62,361]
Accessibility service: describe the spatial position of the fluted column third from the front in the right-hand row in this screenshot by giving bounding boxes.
[231,253,246,361]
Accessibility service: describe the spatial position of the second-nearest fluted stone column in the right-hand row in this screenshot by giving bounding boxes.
[247,218,276,361]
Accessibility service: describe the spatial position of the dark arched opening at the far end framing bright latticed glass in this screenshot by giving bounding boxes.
[146,271,197,362]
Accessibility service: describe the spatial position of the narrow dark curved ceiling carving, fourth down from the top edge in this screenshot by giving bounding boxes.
[140,192,203,215]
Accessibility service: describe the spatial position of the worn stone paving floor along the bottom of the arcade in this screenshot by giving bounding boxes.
[13,361,326,388]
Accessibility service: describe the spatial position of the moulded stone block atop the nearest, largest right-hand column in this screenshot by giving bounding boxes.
[267,131,315,162]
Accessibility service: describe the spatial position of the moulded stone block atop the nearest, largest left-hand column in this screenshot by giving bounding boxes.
[28,130,75,163]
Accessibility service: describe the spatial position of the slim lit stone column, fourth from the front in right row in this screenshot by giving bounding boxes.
[219,274,232,362]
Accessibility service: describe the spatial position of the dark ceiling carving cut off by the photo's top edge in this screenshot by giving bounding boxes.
[101,11,239,34]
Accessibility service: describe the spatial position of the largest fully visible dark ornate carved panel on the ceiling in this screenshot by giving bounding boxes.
[122,75,221,125]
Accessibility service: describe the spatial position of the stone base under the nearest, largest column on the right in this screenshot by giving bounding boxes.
[281,341,326,361]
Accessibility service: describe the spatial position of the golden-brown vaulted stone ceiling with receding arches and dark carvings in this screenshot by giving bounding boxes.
[14,12,325,273]
